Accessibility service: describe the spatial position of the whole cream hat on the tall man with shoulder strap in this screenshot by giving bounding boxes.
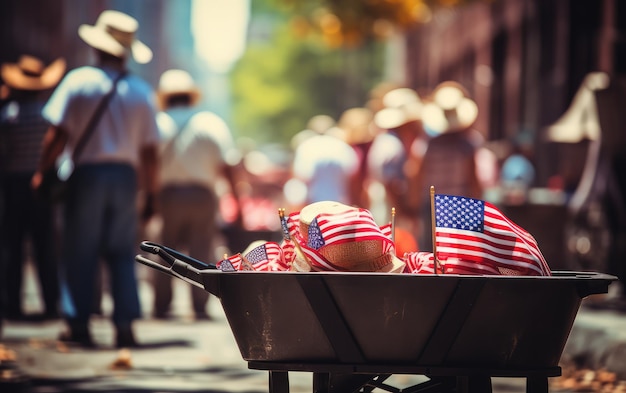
[78,10,152,64]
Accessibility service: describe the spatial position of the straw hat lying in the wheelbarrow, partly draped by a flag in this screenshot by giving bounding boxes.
[299,201,405,273]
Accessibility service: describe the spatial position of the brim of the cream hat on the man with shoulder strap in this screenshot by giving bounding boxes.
[78,25,152,64]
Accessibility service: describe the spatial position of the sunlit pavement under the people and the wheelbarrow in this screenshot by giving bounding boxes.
[0,264,626,393]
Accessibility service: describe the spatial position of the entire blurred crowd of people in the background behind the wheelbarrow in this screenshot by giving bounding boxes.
[0,10,544,347]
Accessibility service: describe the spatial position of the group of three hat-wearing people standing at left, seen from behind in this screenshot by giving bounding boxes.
[0,10,249,347]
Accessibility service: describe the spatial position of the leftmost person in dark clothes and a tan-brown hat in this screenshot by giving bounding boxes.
[0,55,65,319]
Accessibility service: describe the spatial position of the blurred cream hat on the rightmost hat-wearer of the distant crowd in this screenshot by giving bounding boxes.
[422,81,478,134]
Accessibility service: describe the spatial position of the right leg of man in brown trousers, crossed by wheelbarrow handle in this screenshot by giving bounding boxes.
[189,189,217,319]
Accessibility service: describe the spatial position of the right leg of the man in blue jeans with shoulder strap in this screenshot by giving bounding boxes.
[103,165,141,347]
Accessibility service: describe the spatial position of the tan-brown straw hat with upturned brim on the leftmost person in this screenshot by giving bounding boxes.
[1,55,65,90]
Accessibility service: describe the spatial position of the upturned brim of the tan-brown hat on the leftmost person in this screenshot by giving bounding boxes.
[0,58,66,90]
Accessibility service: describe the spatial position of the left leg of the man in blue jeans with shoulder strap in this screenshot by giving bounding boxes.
[59,165,108,345]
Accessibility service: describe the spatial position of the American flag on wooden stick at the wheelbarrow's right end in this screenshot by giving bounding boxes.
[435,194,551,276]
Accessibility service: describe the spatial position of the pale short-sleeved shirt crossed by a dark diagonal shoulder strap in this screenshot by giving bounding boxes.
[43,66,159,166]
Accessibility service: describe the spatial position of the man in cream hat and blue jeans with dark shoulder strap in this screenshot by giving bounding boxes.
[32,10,159,347]
